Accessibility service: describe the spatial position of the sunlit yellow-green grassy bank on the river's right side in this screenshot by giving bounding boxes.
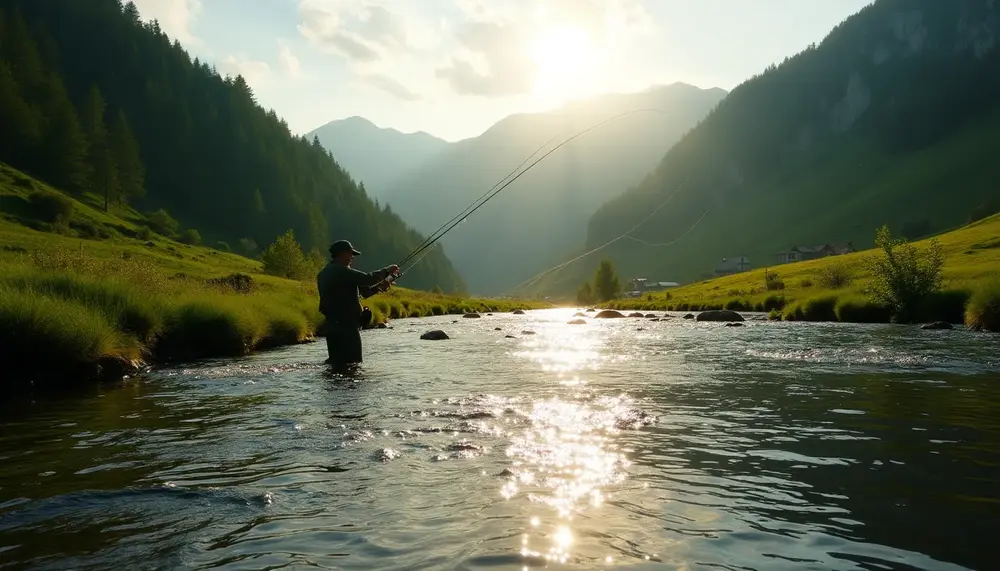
[605,215,1000,330]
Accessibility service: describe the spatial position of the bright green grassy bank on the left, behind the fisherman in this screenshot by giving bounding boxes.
[0,163,539,392]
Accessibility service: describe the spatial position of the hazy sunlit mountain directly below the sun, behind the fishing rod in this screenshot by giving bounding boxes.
[380,83,726,295]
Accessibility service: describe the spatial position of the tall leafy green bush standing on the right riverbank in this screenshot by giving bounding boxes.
[866,226,944,322]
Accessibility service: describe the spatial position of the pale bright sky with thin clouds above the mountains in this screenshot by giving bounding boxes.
[134,0,871,141]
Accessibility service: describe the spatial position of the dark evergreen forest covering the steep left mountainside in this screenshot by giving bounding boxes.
[0,0,464,292]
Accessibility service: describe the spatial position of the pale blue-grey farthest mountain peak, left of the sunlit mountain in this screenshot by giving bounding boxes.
[306,117,451,198]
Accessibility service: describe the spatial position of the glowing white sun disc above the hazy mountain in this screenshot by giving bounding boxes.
[531,25,595,103]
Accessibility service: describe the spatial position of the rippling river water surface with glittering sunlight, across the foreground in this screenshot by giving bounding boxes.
[0,309,1000,571]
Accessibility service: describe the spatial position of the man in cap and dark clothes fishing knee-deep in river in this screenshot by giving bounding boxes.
[316,240,399,366]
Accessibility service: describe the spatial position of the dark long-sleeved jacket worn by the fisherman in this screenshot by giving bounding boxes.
[316,262,389,327]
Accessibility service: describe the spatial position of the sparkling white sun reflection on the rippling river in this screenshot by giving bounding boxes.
[500,324,643,563]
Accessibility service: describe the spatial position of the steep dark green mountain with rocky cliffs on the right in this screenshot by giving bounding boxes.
[524,0,1000,300]
